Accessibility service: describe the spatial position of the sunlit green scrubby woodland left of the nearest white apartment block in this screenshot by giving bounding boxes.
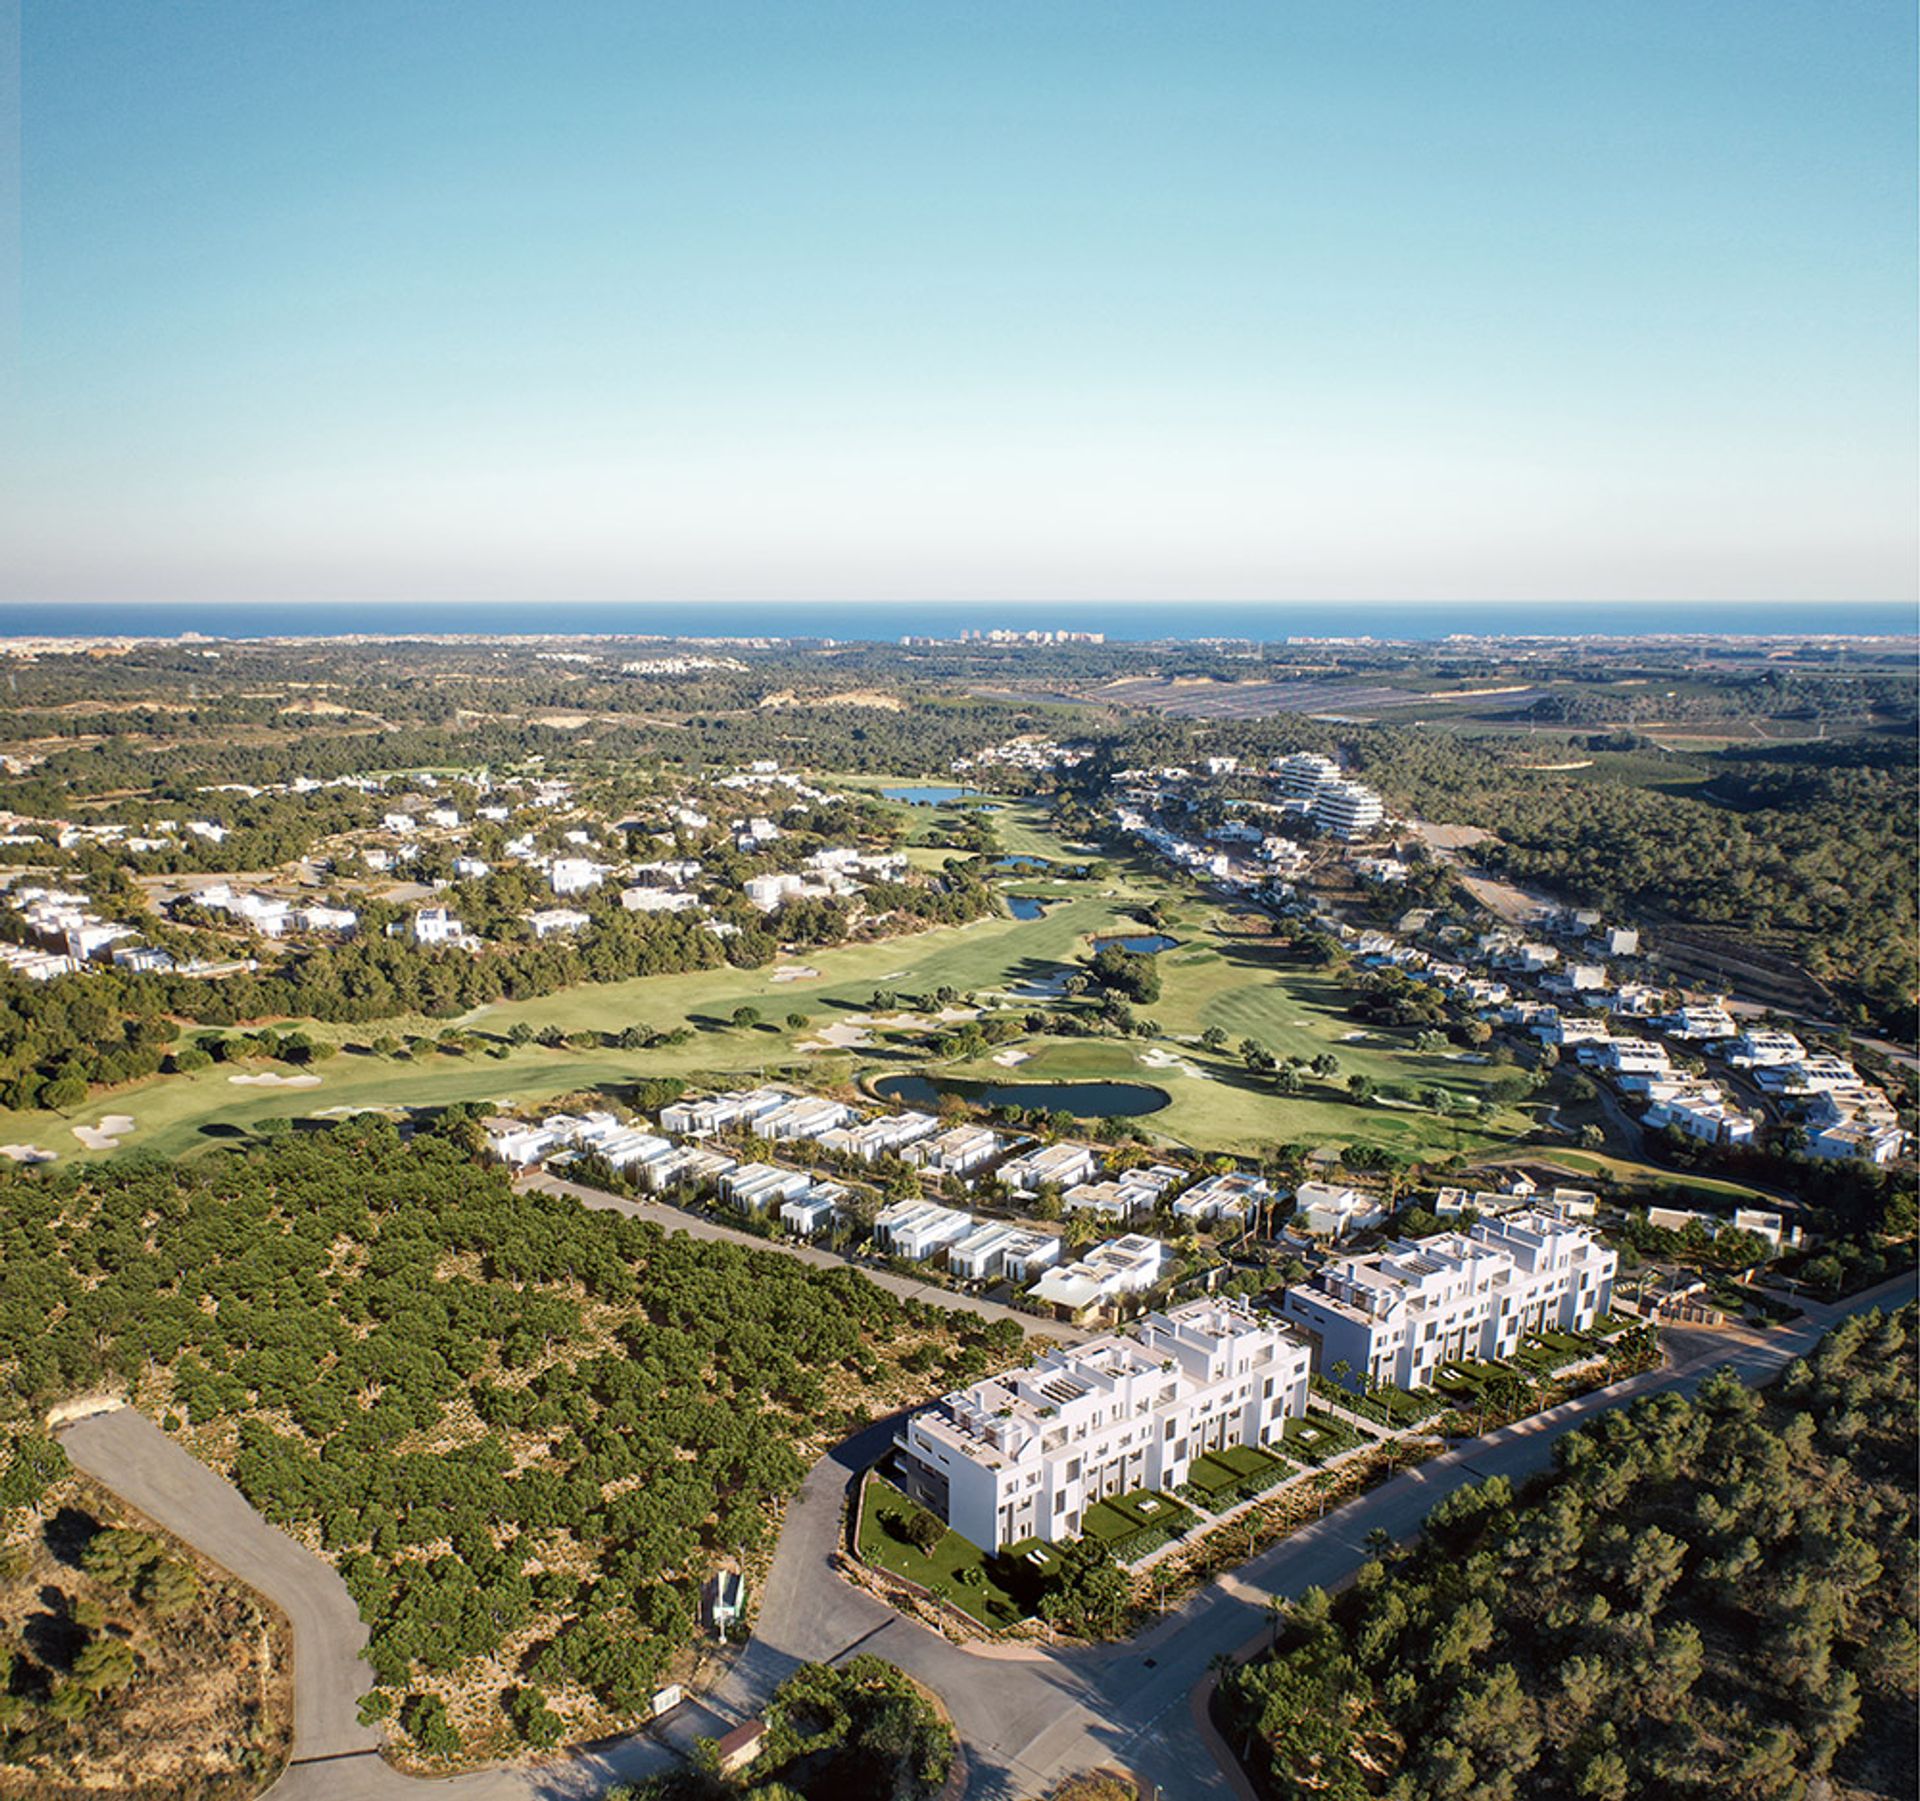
[0,1117,1020,1753]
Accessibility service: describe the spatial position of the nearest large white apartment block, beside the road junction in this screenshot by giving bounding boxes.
[897,1300,1311,1551]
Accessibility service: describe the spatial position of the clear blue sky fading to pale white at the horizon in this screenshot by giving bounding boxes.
[0,0,1916,601]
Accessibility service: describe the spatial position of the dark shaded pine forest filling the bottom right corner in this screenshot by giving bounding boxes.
[1219,1306,1920,1801]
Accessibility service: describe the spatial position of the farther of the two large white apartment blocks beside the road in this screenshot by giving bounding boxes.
[1284,1210,1619,1388]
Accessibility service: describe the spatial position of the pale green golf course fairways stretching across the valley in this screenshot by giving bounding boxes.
[0,803,1543,1167]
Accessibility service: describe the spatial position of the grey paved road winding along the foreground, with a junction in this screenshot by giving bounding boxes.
[61,1275,1914,1801]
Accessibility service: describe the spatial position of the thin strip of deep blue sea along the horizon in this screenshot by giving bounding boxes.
[0,601,1920,641]
